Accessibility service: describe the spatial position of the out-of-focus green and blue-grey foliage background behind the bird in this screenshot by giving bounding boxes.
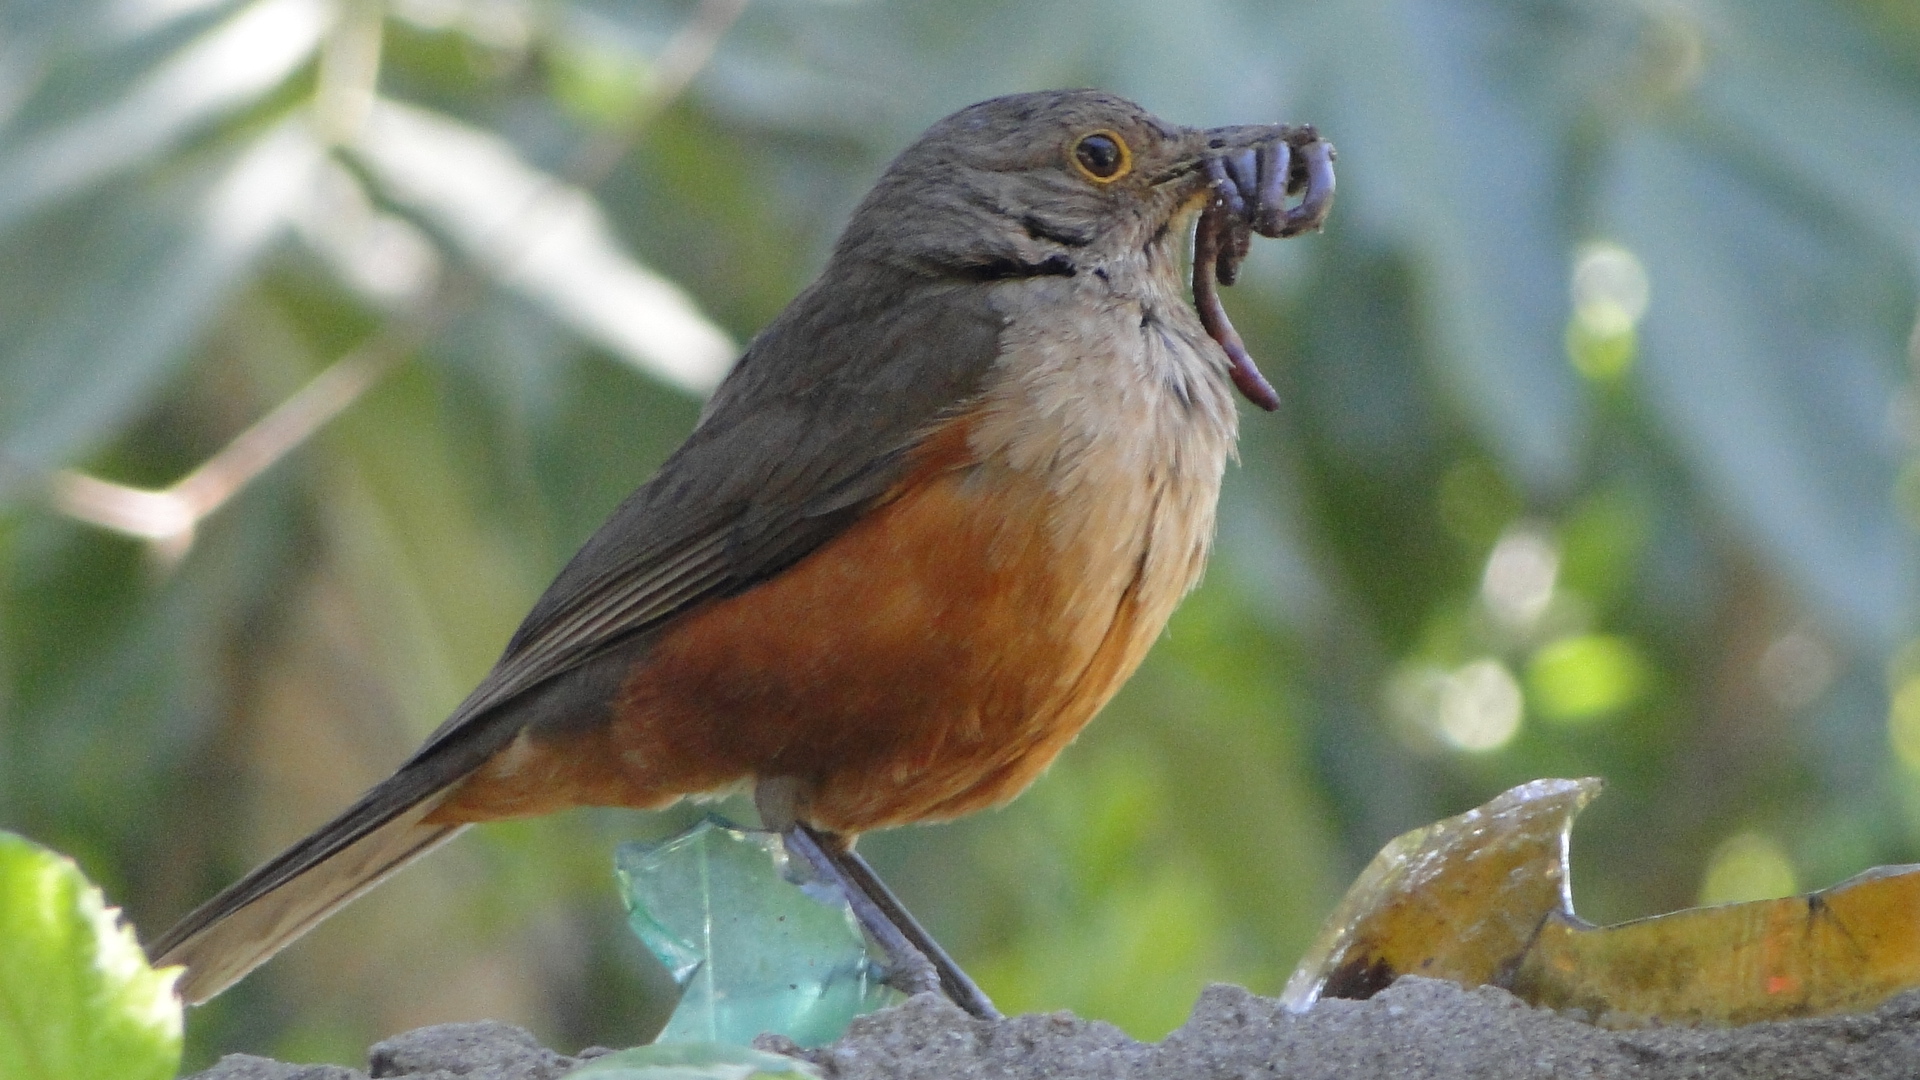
[0,0,1920,1067]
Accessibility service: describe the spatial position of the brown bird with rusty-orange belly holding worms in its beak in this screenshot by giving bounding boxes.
[150,90,1332,1017]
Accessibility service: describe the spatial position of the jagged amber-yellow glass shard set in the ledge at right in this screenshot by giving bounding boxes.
[1281,780,1920,1028]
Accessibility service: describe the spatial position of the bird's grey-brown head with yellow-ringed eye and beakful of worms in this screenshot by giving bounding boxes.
[835,90,1332,407]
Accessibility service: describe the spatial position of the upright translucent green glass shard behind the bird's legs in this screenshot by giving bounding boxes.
[614,817,900,1045]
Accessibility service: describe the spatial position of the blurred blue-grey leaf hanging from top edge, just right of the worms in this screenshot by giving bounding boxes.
[1292,0,1586,486]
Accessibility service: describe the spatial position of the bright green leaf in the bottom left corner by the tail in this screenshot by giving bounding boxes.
[0,832,180,1080]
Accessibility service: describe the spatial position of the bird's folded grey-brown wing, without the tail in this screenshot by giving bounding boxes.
[420,267,1002,755]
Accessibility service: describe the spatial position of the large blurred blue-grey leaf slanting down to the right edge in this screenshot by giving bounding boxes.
[1611,135,1914,650]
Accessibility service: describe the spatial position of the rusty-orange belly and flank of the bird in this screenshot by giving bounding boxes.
[436,413,1159,834]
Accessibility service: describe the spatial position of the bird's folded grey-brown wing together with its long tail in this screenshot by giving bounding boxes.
[152,267,1002,1001]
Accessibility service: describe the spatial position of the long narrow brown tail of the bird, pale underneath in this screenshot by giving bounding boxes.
[148,769,465,1005]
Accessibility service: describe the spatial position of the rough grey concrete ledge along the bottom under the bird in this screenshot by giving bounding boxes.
[192,978,1920,1080]
